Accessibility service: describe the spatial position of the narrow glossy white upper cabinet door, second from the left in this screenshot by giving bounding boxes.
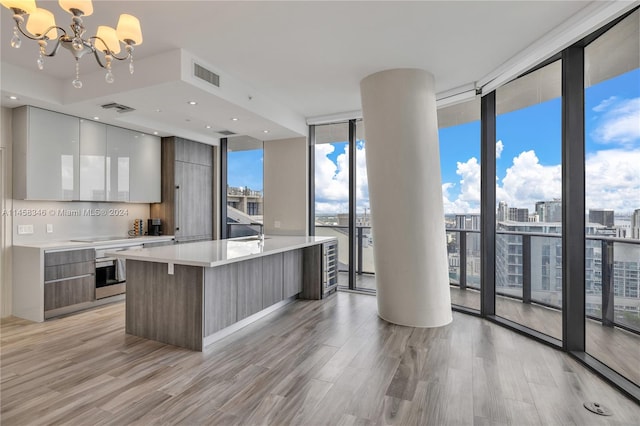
[80,120,107,201]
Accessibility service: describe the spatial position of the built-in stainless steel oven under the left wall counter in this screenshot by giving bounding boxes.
[96,245,142,299]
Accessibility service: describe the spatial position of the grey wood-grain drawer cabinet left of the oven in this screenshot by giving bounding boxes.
[44,249,95,317]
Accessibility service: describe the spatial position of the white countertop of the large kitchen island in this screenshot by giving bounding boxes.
[109,235,335,268]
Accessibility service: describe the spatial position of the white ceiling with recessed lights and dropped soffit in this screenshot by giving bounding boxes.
[0,0,632,143]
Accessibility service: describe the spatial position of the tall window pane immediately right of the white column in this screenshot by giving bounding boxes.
[438,97,480,310]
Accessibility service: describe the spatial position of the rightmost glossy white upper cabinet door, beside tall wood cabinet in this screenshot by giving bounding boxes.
[129,133,161,203]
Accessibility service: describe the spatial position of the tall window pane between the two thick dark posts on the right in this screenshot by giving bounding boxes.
[495,60,562,340]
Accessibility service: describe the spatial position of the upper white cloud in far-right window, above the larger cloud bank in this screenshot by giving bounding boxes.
[593,96,640,145]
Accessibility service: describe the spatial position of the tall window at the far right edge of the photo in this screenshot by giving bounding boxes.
[584,11,640,385]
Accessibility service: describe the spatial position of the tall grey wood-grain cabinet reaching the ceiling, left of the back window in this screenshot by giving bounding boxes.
[151,137,214,242]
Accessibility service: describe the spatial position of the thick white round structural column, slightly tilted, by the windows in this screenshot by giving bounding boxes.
[360,69,452,327]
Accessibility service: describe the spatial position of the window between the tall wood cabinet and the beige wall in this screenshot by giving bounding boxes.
[226,136,264,238]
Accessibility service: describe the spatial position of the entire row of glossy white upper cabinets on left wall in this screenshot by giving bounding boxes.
[12,106,161,203]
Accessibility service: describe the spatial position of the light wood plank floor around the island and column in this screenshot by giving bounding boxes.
[0,292,640,425]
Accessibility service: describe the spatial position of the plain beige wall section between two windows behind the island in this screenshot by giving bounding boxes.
[264,137,309,235]
